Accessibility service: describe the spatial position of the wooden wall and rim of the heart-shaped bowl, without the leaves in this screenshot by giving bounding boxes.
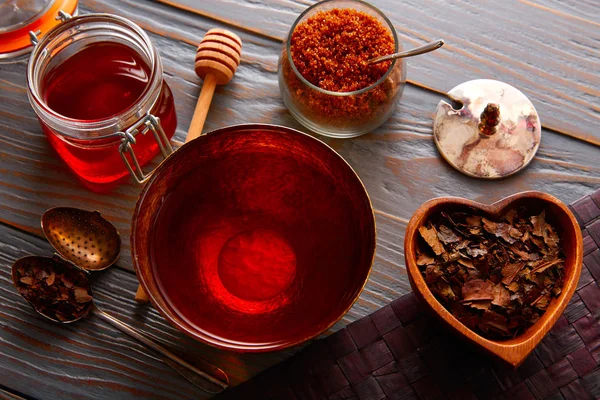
[404,191,583,367]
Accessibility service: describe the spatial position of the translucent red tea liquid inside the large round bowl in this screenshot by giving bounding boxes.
[149,133,372,344]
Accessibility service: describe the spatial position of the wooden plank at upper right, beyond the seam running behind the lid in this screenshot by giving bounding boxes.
[160,0,600,146]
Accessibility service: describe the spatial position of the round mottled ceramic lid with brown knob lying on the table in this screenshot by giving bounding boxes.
[433,79,541,179]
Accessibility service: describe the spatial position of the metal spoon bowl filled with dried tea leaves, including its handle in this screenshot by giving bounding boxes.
[12,256,229,393]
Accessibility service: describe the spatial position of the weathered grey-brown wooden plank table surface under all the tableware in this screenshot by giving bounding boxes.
[0,0,600,399]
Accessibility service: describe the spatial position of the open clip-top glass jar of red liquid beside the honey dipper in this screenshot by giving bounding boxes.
[27,10,177,191]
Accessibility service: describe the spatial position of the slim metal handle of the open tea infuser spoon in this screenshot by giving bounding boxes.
[93,307,229,394]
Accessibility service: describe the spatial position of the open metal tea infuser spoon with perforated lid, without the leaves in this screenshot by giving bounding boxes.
[12,207,229,394]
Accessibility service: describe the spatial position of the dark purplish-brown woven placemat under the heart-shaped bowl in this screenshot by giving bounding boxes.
[219,190,600,400]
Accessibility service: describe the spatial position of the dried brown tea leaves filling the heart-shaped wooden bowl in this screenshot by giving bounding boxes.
[417,207,565,339]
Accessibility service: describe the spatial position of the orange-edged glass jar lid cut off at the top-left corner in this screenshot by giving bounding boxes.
[0,0,78,63]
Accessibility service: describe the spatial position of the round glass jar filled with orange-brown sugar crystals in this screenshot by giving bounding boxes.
[278,0,406,138]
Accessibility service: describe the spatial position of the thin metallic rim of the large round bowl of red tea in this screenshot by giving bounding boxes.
[130,123,377,353]
